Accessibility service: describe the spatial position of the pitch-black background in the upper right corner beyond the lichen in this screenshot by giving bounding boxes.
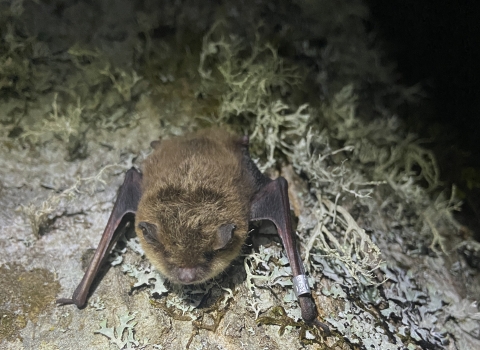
[368,0,480,235]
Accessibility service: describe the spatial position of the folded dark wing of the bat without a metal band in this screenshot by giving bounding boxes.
[57,168,142,308]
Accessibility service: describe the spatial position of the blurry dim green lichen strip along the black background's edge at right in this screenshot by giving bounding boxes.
[314,85,460,252]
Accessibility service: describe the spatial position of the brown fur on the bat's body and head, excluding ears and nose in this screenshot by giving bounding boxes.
[136,129,254,283]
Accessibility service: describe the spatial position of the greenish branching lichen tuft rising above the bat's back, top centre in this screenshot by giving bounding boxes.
[198,23,310,170]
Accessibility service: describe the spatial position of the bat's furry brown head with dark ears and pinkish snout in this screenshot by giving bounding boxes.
[136,186,249,284]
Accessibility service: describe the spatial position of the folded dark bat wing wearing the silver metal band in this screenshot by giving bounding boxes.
[250,177,317,322]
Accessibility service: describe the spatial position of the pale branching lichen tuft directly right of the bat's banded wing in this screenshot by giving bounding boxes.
[293,130,382,284]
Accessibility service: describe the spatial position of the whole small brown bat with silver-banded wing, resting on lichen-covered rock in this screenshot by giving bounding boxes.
[57,129,317,322]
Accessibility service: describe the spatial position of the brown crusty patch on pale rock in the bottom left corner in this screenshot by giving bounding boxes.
[0,264,60,340]
